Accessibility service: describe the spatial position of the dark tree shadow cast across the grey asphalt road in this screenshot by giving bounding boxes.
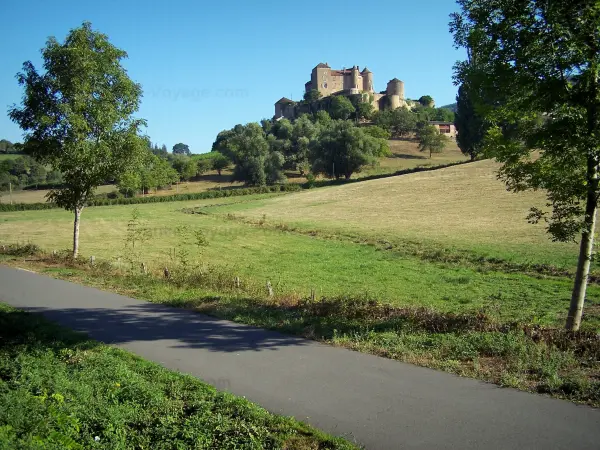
[19,303,306,352]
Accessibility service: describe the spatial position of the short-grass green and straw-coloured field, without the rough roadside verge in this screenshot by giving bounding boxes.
[0,161,600,326]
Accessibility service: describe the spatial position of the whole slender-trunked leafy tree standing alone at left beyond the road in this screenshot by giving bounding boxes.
[9,22,145,258]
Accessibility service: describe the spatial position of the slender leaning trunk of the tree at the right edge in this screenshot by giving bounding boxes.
[566,158,598,331]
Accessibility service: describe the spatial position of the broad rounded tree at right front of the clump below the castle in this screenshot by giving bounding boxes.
[310,120,381,179]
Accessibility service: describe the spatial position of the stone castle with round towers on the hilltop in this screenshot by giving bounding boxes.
[275,63,408,119]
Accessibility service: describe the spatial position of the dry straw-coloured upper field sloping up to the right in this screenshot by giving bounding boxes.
[207,160,577,267]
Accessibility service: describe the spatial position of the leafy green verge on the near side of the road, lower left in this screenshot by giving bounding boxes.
[0,304,352,449]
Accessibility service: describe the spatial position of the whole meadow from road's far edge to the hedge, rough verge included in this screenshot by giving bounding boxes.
[0,161,600,406]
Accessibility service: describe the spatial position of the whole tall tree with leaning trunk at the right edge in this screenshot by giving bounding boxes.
[450,0,600,330]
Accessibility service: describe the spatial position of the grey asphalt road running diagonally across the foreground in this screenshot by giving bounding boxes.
[0,266,600,450]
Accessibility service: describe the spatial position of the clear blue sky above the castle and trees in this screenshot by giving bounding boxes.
[0,0,463,153]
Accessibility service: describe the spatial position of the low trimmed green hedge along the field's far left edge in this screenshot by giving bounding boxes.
[0,184,302,212]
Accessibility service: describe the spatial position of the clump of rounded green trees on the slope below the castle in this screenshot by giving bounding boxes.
[212,110,389,185]
